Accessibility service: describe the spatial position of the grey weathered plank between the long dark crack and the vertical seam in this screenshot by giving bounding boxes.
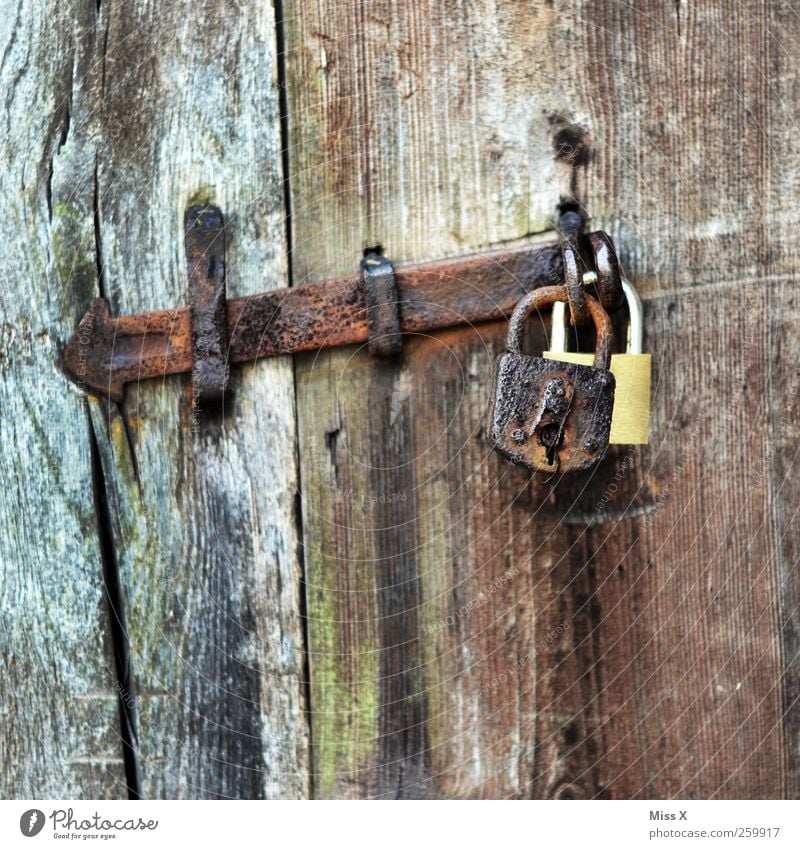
[72,0,308,798]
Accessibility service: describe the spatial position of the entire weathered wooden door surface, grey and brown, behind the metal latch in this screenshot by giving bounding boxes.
[0,0,800,798]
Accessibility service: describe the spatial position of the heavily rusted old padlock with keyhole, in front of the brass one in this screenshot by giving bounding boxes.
[488,286,615,473]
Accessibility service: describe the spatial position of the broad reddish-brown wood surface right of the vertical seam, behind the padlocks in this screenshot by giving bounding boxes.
[287,0,800,798]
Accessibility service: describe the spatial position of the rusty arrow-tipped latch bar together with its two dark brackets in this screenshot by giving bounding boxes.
[62,207,624,401]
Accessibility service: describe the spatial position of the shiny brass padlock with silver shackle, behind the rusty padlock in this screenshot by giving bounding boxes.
[542,274,652,445]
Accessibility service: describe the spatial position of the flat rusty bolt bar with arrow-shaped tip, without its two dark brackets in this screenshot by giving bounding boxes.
[63,233,562,401]
